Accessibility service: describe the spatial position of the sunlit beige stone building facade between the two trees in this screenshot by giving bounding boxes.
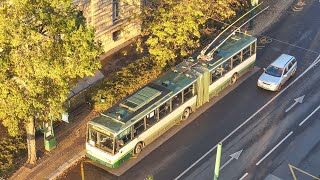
[74,0,143,54]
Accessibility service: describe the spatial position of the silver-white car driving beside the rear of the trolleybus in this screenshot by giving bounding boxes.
[257,54,297,91]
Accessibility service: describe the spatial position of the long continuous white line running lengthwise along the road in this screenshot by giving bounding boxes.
[174,55,320,180]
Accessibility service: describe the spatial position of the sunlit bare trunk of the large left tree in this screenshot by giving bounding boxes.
[26,117,37,164]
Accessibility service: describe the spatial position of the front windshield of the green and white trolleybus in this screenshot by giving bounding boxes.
[88,128,114,154]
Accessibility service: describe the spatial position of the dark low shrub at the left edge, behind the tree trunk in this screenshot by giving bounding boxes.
[0,136,26,176]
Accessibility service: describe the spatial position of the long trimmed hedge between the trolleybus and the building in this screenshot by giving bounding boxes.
[88,56,162,111]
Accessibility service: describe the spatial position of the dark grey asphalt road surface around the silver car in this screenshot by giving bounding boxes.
[60,1,320,180]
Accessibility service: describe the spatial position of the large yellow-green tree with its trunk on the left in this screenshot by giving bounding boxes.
[0,0,102,164]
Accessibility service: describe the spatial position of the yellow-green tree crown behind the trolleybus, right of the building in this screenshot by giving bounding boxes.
[142,0,238,66]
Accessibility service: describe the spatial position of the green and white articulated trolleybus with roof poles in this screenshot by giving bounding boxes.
[86,31,256,168]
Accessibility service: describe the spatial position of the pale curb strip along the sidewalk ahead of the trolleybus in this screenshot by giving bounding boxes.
[46,150,86,180]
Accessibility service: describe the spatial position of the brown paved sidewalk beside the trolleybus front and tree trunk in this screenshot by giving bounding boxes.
[9,108,93,180]
